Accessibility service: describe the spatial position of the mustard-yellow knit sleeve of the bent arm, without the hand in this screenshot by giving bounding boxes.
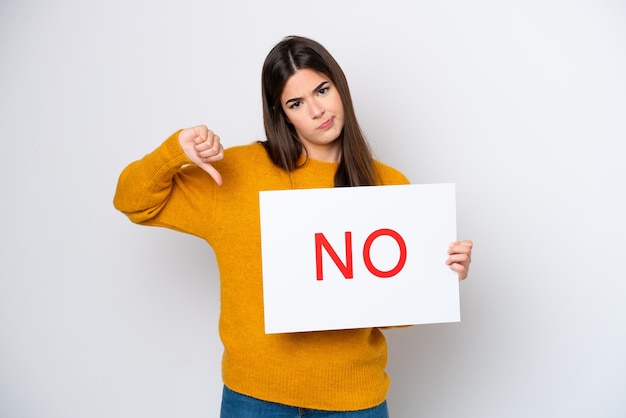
[113,131,214,237]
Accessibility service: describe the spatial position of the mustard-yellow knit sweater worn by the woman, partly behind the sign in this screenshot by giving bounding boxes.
[114,133,408,411]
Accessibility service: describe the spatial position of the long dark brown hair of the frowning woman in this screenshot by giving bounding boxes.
[261,36,377,187]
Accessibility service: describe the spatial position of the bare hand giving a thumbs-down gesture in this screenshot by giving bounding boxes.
[178,125,224,186]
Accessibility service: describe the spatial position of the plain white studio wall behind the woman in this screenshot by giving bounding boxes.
[0,0,626,418]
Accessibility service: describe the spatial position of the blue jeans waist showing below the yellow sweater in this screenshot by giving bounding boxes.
[220,386,389,418]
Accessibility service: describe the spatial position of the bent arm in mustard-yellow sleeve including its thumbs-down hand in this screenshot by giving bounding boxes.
[113,126,224,235]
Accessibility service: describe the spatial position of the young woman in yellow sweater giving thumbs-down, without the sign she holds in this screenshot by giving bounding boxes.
[114,37,472,418]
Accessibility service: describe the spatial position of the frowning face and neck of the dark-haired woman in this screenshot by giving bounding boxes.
[280,69,344,162]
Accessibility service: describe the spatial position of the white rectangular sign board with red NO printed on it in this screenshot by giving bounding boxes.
[259,184,460,334]
